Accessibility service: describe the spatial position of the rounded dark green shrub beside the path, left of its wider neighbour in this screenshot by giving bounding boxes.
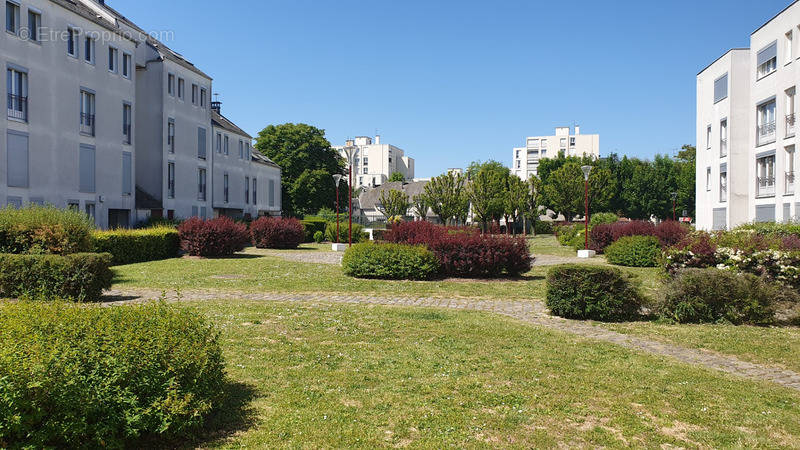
[547,264,644,322]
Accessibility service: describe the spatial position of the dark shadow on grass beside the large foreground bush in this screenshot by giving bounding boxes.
[135,380,256,449]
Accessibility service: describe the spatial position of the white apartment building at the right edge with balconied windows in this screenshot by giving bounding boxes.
[697,2,800,230]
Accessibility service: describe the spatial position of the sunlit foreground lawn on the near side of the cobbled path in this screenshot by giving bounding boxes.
[193,301,800,448]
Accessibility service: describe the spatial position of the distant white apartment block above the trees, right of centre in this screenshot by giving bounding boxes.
[511,125,600,180]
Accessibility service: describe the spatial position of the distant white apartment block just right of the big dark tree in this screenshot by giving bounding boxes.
[334,136,414,188]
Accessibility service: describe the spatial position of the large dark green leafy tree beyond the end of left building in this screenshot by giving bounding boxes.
[255,123,347,217]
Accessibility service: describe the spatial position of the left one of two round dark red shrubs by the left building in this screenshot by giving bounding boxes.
[178,217,250,257]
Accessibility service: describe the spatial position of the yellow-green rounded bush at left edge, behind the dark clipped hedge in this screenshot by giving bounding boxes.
[0,205,94,255]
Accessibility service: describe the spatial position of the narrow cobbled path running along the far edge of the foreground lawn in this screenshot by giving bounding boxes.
[106,290,800,391]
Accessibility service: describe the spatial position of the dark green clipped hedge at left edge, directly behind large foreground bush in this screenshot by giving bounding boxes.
[0,253,114,302]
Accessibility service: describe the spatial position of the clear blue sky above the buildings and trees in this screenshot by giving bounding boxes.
[115,0,790,177]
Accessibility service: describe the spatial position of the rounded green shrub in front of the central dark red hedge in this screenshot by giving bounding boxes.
[342,242,439,280]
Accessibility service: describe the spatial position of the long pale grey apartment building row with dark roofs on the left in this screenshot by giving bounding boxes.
[0,0,280,228]
